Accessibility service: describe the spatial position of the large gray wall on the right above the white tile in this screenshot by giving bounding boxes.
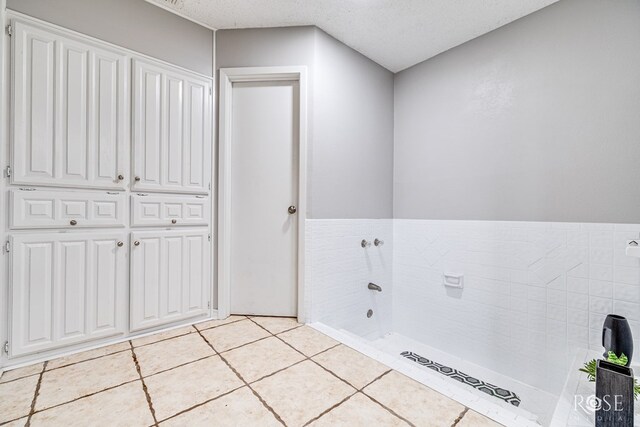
[394,0,640,223]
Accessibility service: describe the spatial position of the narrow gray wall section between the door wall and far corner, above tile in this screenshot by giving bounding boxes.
[311,30,393,218]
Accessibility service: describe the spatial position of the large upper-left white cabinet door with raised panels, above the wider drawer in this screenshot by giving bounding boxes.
[12,20,129,189]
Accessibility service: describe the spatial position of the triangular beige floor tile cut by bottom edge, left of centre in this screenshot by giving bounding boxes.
[160,387,282,427]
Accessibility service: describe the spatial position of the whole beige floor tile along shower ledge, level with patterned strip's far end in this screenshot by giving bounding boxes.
[313,345,389,389]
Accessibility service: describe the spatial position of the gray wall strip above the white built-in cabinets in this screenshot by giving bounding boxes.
[7,0,213,76]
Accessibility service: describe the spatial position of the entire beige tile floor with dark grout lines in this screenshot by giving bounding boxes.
[0,316,498,427]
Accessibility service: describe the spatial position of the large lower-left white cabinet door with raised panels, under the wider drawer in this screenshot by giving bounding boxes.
[9,232,127,357]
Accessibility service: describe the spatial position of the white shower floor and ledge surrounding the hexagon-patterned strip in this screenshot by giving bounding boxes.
[312,323,558,426]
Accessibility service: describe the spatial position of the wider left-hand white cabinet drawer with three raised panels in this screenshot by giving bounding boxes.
[9,188,127,229]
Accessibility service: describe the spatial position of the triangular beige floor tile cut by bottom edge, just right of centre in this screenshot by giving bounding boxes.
[310,393,409,427]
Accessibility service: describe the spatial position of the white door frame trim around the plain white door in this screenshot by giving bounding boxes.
[218,66,307,323]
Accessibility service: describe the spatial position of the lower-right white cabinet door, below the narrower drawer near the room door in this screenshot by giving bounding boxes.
[130,229,211,331]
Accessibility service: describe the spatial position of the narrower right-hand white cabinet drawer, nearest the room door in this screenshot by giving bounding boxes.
[131,194,210,226]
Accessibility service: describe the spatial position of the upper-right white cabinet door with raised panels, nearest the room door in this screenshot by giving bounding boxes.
[132,59,212,194]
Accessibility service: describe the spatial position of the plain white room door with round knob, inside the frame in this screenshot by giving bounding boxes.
[229,81,299,316]
